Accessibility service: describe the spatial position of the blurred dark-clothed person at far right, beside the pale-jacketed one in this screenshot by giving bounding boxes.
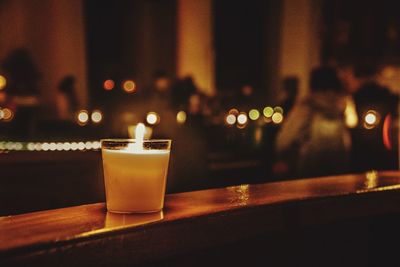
[351,64,398,171]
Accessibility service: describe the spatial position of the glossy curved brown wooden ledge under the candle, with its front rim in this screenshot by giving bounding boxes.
[0,171,400,266]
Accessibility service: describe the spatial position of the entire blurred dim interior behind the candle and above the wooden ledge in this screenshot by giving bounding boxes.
[0,0,400,214]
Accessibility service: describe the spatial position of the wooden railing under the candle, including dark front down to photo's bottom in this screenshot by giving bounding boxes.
[0,172,400,266]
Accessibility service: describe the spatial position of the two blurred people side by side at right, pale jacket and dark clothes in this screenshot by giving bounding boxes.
[276,64,398,180]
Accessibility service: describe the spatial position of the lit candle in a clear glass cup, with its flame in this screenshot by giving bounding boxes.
[102,124,171,213]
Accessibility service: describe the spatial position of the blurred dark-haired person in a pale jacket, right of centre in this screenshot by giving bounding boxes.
[274,67,350,177]
